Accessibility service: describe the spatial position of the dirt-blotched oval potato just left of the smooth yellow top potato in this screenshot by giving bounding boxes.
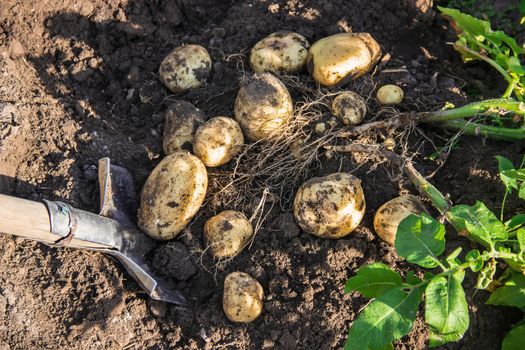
[250,31,310,73]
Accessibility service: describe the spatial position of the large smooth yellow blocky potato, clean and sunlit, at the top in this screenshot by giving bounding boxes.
[306,33,381,86]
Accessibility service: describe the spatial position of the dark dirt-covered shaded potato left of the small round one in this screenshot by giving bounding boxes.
[162,101,206,155]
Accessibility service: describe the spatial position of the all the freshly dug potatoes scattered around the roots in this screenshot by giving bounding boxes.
[138,31,414,322]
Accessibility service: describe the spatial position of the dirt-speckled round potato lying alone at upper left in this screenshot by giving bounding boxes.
[159,45,211,92]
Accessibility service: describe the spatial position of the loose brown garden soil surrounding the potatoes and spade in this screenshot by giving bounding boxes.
[0,0,525,350]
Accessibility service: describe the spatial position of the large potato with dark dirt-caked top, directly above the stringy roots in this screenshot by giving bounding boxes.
[234,73,293,141]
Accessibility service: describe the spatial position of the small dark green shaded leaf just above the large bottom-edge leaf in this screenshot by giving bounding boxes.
[345,262,403,298]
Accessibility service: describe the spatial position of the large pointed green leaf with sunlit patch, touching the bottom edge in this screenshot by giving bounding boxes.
[344,288,422,350]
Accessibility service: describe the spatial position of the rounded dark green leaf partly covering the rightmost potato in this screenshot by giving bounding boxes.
[395,213,445,268]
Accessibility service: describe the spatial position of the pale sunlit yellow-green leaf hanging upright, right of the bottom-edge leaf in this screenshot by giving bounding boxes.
[425,271,469,347]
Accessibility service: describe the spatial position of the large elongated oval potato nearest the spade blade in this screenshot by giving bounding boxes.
[138,152,208,240]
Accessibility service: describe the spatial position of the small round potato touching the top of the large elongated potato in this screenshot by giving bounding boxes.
[193,117,244,167]
